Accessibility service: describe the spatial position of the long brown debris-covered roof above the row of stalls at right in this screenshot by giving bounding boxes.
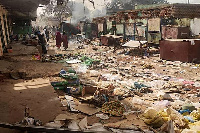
[93,4,200,22]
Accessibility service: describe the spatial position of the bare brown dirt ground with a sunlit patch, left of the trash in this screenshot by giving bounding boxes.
[0,42,73,133]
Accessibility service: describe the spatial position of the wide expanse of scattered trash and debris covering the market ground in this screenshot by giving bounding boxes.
[45,42,200,133]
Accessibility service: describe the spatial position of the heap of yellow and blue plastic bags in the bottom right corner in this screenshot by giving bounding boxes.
[140,101,200,133]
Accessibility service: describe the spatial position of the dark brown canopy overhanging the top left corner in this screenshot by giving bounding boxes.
[0,0,50,19]
